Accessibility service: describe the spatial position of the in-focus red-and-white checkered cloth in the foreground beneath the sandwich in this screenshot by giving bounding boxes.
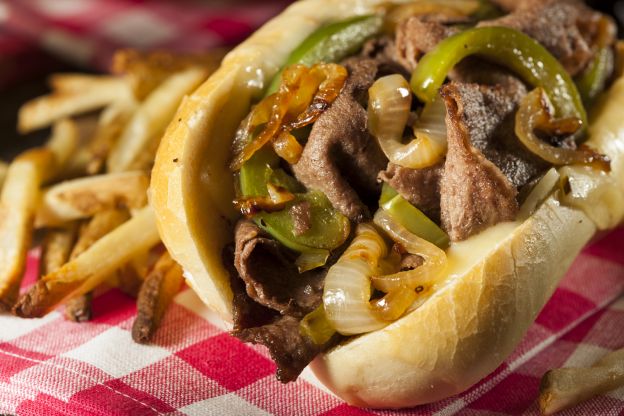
[0,228,624,416]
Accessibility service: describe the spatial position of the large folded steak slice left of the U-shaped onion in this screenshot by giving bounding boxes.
[292,57,387,222]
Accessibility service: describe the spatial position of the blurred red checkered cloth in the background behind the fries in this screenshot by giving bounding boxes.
[0,0,290,82]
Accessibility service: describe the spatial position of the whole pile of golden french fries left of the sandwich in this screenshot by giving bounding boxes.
[0,50,223,342]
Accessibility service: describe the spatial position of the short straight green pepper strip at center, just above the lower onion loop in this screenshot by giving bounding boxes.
[379,184,449,249]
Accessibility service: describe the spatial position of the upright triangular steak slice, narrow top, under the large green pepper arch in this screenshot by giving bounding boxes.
[440,83,518,241]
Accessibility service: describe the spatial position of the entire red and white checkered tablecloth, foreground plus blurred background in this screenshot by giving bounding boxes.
[0,0,624,416]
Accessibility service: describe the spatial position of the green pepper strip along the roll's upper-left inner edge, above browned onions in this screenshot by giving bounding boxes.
[266,15,383,95]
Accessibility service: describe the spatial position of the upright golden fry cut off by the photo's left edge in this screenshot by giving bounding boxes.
[0,148,55,309]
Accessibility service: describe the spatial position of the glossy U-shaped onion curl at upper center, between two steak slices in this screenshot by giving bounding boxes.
[368,74,447,169]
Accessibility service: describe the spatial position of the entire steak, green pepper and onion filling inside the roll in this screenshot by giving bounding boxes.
[223,0,616,382]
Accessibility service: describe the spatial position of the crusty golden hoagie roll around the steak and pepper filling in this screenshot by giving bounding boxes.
[150,0,624,408]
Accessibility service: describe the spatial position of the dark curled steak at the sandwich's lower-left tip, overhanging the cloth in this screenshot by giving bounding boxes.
[223,224,331,383]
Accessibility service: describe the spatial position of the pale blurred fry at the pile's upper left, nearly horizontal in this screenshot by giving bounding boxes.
[18,75,132,133]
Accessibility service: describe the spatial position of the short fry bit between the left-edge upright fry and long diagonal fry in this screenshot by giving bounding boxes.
[39,222,78,276]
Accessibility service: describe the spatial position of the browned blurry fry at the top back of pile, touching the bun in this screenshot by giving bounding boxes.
[112,49,227,100]
